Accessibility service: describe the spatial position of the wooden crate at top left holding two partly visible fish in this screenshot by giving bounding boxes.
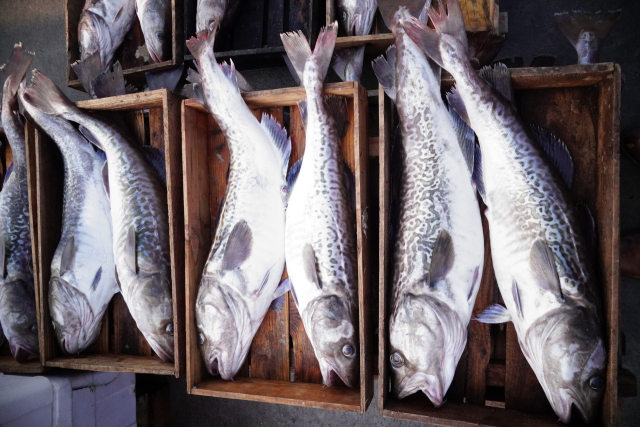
[65,0,185,91]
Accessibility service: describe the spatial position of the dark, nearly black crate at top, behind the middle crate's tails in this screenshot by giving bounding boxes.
[184,0,324,70]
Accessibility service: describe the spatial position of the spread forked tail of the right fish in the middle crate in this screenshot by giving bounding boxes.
[280,21,338,86]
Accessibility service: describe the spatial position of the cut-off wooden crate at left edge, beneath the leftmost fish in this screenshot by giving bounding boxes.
[0,124,44,374]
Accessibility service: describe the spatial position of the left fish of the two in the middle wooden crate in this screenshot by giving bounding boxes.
[187,21,291,380]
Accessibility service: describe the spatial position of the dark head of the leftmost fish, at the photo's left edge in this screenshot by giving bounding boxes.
[0,279,39,362]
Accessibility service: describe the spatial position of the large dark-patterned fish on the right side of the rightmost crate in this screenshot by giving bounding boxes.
[403,0,606,423]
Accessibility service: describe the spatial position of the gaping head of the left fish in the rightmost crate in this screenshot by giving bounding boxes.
[389,294,466,407]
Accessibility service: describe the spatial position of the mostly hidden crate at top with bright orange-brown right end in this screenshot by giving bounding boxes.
[325,0,500,55]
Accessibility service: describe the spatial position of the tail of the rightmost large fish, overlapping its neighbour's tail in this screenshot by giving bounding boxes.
[400,0,467,68]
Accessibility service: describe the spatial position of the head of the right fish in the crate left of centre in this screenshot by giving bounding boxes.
[127,271,174,362]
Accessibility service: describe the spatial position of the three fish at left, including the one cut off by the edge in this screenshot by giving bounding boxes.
[0,45,174,361]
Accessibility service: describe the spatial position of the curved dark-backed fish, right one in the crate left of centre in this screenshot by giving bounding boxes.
[22,71,174,362]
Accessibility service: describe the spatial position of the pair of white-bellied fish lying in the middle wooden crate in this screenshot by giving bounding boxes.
[187,21,359,387]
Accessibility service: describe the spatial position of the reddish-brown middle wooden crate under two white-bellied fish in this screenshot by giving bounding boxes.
[182,82,373,412]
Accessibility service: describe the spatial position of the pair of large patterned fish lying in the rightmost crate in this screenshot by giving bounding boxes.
[373,0,606,423]
